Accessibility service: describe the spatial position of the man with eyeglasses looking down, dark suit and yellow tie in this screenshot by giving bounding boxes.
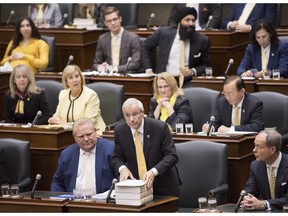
[202,76,264,133]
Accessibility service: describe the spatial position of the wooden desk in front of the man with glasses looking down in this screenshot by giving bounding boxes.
[103,131,255,202]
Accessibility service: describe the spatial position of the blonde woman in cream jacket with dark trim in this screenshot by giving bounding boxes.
[48,65,106,135]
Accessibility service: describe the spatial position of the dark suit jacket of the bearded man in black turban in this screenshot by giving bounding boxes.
[141,26,210,86]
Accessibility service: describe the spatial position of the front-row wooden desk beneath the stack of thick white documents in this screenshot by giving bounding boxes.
[67,196,179,213]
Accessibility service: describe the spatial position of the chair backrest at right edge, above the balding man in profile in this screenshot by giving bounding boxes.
[251,91,288,135]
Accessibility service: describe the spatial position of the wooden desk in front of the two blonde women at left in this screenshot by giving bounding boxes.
[0,127,75,190]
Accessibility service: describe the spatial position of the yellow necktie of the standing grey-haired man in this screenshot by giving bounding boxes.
[134,131,147,179]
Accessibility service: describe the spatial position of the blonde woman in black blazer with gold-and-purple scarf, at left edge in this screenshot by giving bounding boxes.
[4,65,50,124]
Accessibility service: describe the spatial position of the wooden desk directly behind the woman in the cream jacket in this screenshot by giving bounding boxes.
[35,72,154,114]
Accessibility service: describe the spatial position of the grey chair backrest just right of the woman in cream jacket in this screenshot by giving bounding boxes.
[86,82,124,125]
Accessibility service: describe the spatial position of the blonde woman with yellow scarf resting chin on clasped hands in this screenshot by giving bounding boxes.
[149,72,193,130]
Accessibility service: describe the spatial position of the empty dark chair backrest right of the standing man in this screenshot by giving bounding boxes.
[175,141,228,209]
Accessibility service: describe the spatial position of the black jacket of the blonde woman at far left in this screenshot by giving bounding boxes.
[4,91,51,125]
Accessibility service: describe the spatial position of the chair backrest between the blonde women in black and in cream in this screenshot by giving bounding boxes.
[36,80,64,115]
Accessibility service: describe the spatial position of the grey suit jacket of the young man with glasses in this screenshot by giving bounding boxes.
[93,30,141,73]
